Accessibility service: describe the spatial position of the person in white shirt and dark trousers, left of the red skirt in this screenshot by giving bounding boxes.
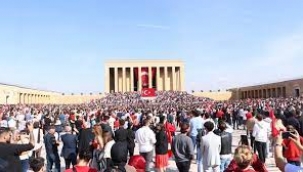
[136,118,157,172]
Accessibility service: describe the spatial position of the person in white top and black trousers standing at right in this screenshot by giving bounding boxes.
[252,114,270,163]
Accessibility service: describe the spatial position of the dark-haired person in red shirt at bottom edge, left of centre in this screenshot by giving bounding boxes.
[65,150,98,172]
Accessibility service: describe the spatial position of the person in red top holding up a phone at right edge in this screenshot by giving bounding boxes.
[282,125,303,166]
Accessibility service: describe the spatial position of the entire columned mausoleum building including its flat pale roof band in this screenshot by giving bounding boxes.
[104,60,185,93]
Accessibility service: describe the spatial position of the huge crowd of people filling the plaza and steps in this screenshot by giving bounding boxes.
[0,91,303,172]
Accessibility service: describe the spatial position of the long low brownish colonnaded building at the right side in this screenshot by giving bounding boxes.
[229,78,303,99]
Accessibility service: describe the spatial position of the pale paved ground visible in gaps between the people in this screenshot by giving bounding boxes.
[42,130,279,172]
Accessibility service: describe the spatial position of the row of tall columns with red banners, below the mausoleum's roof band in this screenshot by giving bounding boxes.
[105,65,184,92]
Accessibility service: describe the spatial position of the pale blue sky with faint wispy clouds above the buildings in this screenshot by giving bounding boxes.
[0,0,303,93]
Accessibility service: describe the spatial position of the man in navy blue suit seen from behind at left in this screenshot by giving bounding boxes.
[61,126,77,169]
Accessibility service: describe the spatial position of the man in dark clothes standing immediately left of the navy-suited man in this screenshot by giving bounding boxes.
[44,125,61,171]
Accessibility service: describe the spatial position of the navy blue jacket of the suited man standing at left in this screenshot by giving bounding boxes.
[61,133,77,159]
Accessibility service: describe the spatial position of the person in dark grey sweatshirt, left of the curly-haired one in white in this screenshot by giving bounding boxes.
[171,123,194,172]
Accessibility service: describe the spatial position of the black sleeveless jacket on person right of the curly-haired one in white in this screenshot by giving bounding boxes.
[214,129,232,155]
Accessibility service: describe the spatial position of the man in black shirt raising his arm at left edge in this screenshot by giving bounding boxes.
[0,124,35,172]
